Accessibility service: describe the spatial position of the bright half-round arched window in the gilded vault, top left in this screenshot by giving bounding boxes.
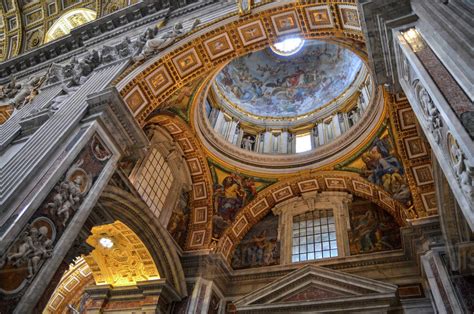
[44,8,97,43]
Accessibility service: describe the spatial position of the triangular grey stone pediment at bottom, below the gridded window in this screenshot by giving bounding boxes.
[234,265,397,313]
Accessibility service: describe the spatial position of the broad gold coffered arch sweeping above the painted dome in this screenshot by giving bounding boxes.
[117,0,367,124]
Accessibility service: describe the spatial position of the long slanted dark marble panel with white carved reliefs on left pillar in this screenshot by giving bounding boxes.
[0,134,112,313]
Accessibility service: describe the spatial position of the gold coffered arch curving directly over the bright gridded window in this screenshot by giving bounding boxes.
[216,171,410,262]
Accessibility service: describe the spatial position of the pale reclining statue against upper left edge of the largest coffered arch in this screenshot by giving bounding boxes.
[133,19,201,62]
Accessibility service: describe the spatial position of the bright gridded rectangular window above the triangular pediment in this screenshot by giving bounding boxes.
[291,209,338,262]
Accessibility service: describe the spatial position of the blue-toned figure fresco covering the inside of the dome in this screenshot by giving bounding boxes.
[216,40,363,118]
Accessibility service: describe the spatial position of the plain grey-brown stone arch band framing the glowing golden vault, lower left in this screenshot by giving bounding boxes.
[98,186,187,297]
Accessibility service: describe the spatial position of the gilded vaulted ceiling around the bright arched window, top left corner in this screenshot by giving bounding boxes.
[0,0,140,61]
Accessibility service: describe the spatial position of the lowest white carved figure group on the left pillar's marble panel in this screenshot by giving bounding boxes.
[8,226,53,278]
